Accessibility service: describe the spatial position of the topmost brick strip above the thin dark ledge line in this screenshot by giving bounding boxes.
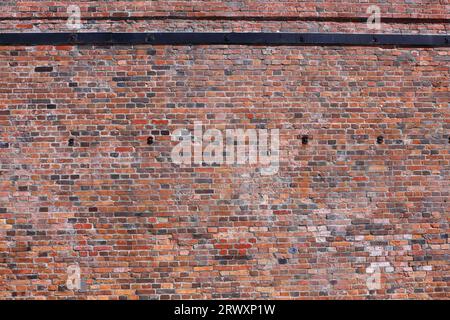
[0,0,450,19]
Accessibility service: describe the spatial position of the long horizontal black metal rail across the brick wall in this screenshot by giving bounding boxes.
[0,32,450,47]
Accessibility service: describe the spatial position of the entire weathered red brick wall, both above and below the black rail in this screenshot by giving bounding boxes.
[0,1,450,299]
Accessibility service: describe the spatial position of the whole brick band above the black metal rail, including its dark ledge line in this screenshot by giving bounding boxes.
[0,0,450,34]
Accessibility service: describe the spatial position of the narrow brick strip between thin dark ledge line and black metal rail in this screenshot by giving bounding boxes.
[0,19,450,34]
